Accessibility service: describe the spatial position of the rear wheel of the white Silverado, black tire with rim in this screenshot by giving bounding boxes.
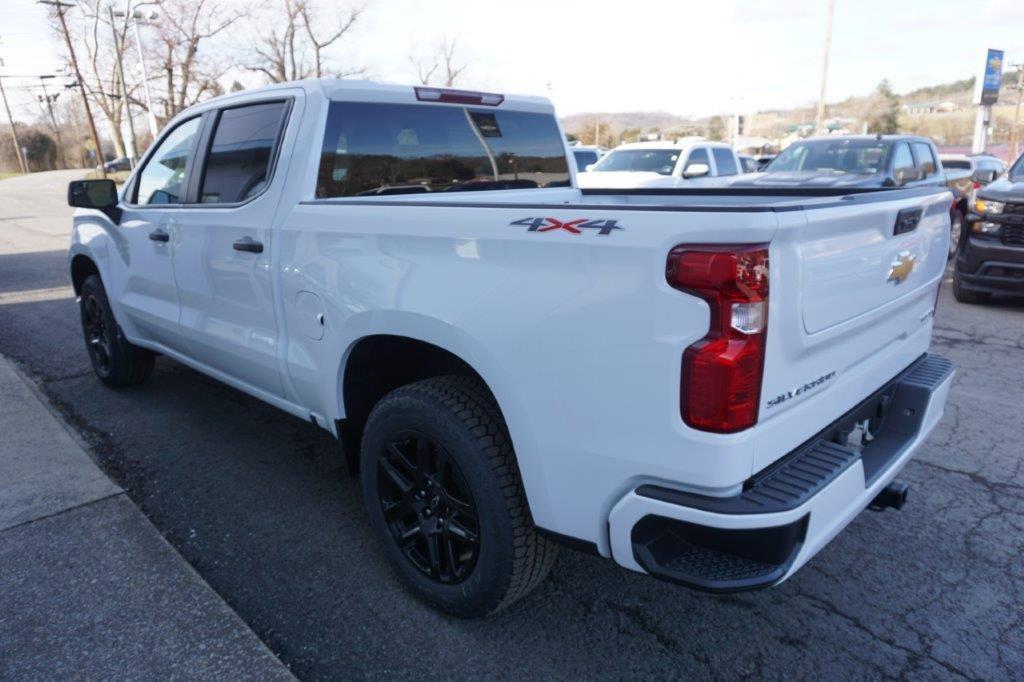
[360,376,558,617]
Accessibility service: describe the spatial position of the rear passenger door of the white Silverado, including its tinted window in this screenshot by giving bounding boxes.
[169,97,293,396]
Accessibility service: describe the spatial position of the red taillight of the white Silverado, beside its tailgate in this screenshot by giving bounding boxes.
[668,244,768,433]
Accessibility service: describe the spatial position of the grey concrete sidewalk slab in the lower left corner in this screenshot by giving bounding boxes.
[0,355,294,680]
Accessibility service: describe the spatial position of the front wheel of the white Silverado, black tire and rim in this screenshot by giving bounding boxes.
[78,274,156,388]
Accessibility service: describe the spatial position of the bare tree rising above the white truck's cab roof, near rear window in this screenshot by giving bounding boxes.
[248,0,364,83]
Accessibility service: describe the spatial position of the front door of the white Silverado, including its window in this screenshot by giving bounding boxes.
[115,116,202,351]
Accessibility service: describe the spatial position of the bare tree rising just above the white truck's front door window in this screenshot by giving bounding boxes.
[156,0,240,120]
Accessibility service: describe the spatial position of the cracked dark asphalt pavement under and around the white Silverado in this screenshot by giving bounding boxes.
[0,173,1024,679]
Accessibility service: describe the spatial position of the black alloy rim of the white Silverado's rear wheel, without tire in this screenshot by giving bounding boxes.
[377,430,480,585]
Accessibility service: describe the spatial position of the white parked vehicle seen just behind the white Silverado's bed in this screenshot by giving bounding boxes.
[580,138,743,188]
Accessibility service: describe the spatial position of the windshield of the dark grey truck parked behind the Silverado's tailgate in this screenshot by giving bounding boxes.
[765,139,890,175]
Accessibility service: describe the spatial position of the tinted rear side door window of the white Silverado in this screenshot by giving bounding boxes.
[200,101,288,204]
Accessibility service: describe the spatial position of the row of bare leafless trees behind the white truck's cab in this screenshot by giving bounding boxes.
[0,0,469,170]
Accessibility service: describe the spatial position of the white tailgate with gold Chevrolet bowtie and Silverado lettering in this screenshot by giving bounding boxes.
[753,190,951,471]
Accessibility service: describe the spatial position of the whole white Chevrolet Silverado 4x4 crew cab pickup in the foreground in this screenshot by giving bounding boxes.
[69,80,952,616]
